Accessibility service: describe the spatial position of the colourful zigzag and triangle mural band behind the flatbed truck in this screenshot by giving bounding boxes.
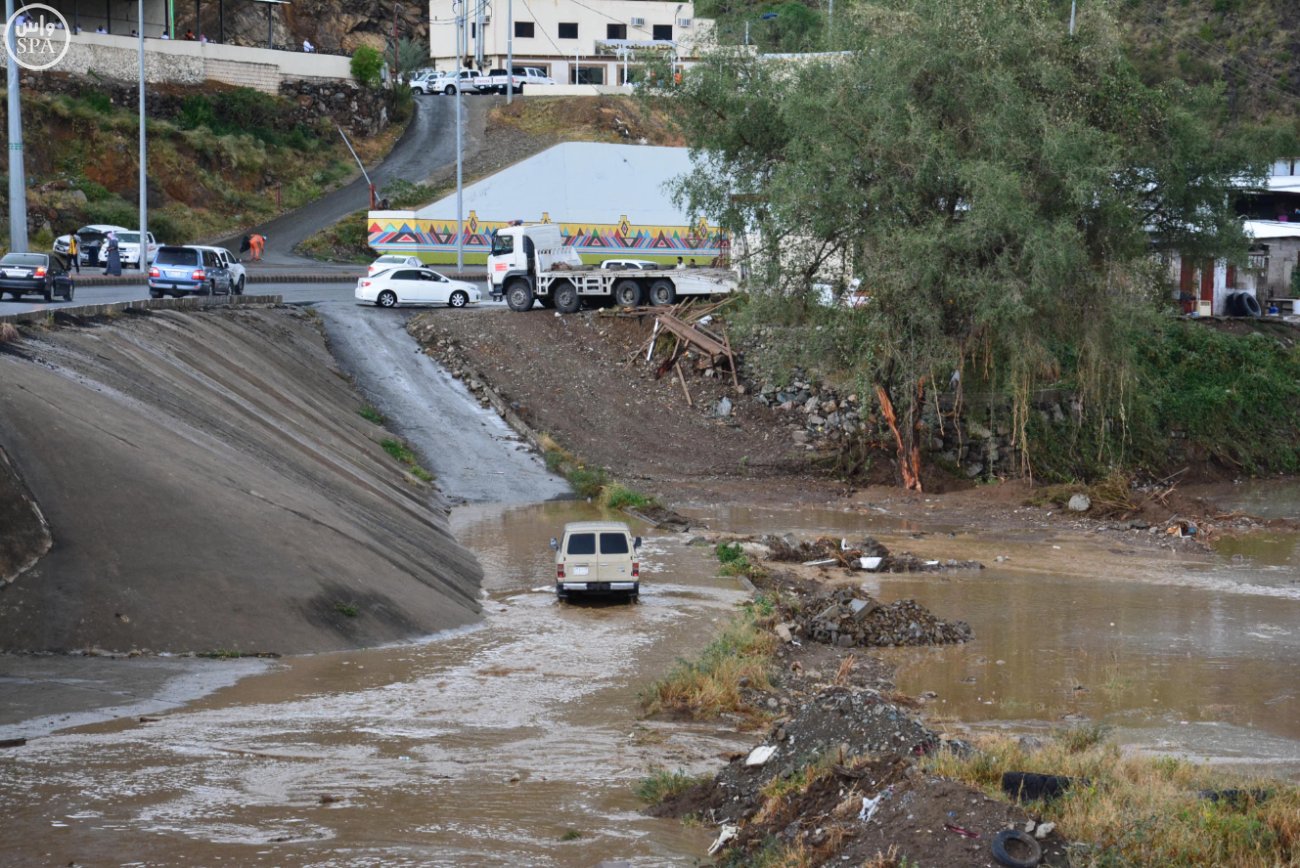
[369,211,731,265]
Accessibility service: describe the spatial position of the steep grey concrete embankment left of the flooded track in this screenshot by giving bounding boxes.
[0,308,481,652]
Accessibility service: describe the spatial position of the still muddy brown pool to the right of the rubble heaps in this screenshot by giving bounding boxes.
[692,483,1300,780]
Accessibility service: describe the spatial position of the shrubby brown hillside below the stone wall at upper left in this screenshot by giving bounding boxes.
[0,74,399,247]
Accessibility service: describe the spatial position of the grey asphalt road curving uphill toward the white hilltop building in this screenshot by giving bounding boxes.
[216,96,489,268]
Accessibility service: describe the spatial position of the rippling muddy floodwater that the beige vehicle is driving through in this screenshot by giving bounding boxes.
[0,502,744,865]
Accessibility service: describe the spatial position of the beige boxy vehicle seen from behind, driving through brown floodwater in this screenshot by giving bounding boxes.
[551,521,641,600]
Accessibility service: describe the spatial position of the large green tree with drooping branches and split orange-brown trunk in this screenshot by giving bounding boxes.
[672,0,1266,489]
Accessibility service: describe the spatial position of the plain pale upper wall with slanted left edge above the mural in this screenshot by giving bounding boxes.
[415,142,692,226]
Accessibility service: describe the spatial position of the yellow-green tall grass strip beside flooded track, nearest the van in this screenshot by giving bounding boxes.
[641,607,776,720]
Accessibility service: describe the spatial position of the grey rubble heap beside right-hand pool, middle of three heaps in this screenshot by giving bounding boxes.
[794,587,975,648]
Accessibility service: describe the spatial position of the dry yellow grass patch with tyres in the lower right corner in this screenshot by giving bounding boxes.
[922,728,1300,868]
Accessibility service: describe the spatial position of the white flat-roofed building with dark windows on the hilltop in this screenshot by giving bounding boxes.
[429,0,712,84]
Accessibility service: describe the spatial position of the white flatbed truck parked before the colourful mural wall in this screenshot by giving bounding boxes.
[488,223,737,313]
